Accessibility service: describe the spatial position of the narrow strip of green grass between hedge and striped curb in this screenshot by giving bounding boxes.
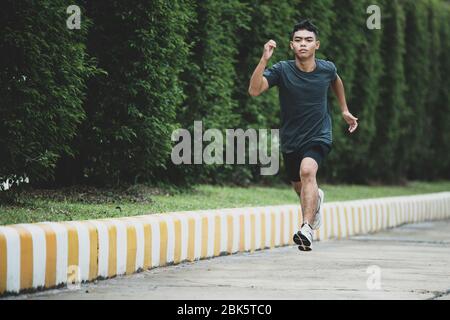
[0,181,450,225]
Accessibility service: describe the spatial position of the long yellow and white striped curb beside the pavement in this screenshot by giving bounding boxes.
[0,192,450,295]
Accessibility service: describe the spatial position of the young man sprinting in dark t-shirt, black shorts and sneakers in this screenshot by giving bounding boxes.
[248,19,358,251]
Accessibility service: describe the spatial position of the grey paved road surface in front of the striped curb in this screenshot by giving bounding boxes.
[4,221,450,300]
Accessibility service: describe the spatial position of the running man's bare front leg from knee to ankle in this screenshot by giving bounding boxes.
[300,158,319,225]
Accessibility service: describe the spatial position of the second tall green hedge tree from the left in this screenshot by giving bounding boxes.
[60,0,193,185]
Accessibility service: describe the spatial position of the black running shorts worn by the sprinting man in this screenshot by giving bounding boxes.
[283,143,331,182]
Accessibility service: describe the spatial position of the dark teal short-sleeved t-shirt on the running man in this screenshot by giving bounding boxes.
[264,59,337,153]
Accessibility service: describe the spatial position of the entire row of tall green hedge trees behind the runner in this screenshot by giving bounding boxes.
[0,0,450,194]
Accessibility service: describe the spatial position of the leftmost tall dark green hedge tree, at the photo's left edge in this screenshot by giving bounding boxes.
[0,0,95,186]
